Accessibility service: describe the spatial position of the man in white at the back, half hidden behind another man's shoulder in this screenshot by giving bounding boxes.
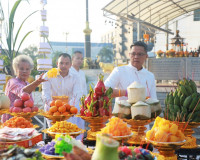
[70,51,87,96]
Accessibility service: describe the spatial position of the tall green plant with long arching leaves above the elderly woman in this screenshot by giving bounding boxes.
[0,0,37,76]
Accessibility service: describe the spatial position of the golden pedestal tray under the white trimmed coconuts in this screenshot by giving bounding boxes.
[123,118,154,145]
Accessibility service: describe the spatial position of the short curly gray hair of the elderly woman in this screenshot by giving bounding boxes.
[12,55,34,75]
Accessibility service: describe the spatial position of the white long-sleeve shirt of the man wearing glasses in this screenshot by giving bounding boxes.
[105,63,157,100]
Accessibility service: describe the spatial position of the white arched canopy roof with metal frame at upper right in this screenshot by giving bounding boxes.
[102,0,200,34]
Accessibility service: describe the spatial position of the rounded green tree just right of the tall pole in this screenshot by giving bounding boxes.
[98,47,114,63]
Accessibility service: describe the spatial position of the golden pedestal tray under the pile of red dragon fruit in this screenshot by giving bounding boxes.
[77,115,110,141]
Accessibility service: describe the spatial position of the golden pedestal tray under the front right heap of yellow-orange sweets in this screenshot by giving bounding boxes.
[146,139,186,160]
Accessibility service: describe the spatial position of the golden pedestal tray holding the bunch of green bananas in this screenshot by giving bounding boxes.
[173,122,200,148]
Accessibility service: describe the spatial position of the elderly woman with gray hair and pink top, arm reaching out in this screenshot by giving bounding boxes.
[1,55,46,123]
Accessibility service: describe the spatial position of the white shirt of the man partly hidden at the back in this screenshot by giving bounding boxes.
[70,66,87,96]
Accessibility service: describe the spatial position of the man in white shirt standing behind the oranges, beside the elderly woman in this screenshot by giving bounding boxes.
[42,53,84,135]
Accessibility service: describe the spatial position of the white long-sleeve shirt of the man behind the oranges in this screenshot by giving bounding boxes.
[42,70,81,108]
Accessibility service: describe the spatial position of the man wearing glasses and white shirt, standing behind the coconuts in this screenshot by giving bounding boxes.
[105,41,157,109]
